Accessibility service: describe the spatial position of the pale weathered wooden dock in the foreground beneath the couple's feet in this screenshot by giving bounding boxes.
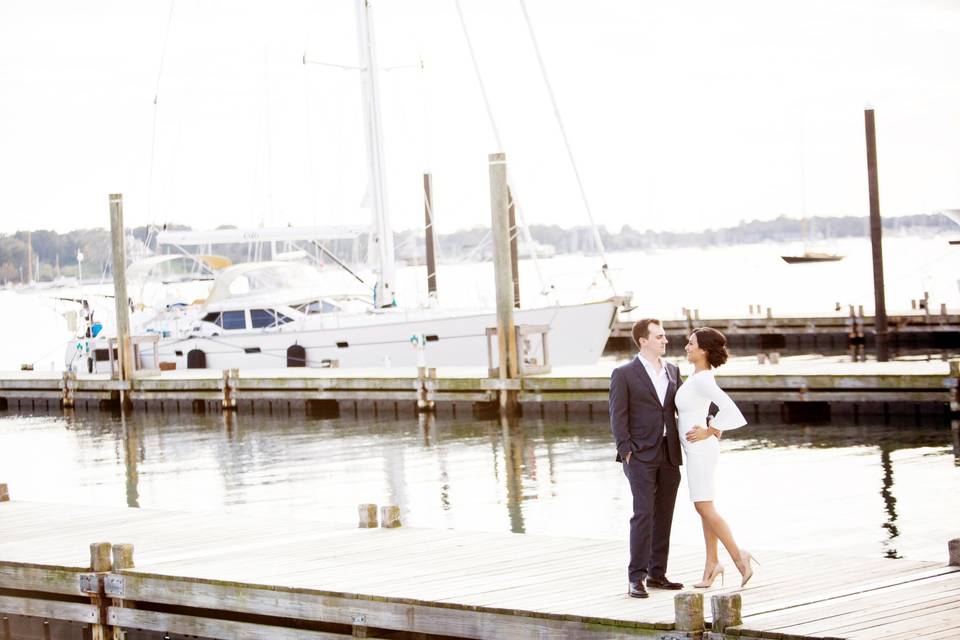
[0,492,960,640]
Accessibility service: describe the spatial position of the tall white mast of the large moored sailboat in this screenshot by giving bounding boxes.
[355,0,396,307]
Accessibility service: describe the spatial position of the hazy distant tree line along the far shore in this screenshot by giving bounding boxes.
[0,214,960,285]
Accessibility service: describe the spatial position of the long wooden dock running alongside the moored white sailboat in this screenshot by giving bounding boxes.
[0,357,960,420]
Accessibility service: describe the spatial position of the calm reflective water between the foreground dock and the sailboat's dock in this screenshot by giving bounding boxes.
[0,412,960,559]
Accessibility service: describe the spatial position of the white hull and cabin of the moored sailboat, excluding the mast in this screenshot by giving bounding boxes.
[67,261,617,372]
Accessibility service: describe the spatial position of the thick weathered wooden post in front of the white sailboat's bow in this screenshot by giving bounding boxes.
[489,153,518,415]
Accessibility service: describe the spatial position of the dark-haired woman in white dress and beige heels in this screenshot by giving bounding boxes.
[676,327,754,589]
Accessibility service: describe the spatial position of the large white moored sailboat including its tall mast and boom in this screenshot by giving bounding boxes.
[67,0,619,372]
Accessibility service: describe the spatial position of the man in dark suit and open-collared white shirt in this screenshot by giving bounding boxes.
[610,318,683,598]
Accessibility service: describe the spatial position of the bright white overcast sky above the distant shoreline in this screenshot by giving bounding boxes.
[0,0,960,232]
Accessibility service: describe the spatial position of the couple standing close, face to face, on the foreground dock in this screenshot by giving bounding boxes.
[610,318,753,598]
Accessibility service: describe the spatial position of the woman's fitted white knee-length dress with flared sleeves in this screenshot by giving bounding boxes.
[675,369,747,502]
